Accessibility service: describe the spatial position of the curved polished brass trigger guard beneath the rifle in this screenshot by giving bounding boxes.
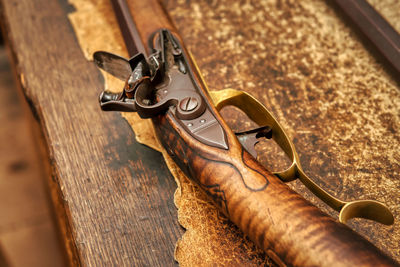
[210,89,394,225]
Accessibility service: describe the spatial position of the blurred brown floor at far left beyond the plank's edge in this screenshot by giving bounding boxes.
[0,34,66,267]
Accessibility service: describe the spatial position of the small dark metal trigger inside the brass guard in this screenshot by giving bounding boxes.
[235,126,272,159]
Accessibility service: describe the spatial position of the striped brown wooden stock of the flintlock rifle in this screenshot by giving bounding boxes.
[107,0,397,266]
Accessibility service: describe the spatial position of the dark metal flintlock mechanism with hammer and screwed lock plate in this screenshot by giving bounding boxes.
[94,29,228,149]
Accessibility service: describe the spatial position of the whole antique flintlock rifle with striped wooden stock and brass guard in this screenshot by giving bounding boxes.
[94,0,397,266]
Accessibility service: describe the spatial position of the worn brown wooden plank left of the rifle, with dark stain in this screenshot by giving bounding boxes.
[2,0,182,265]
